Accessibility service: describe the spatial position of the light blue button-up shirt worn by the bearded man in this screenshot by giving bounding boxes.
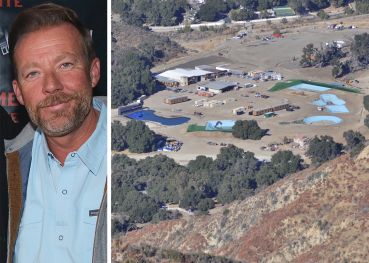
[14,99,107,263]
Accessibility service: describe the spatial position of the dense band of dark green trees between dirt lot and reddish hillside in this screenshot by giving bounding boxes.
[112,145,304,228]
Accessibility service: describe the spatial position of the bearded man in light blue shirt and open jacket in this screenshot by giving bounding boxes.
[7,4,107,263]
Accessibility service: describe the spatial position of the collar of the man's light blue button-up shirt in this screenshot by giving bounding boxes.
[37,98,107,175]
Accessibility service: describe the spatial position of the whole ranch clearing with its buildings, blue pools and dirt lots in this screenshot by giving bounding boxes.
[112,13,369,164]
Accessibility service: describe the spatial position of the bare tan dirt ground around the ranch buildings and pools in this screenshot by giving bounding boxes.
[112,14,369,164]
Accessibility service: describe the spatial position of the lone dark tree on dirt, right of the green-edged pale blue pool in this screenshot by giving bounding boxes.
[232,120,267,140]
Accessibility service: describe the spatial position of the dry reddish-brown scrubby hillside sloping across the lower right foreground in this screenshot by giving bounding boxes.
[112,148,369,262]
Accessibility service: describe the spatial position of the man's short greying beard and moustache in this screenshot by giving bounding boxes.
[26,88,92,137]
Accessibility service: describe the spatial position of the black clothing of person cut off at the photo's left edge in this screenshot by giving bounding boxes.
[0,106,24,262]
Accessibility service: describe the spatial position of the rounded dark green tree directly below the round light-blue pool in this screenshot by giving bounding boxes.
[306,136,343,165]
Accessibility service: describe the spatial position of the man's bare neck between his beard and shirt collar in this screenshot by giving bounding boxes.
[45,108,99,165]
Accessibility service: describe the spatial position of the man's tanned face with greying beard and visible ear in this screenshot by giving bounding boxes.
[13,24,100,136]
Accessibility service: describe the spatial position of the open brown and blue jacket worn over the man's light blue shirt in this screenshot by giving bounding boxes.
[4,125,107,263]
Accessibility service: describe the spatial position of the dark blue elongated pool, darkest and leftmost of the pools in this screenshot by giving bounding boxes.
[125,110,190,126]
